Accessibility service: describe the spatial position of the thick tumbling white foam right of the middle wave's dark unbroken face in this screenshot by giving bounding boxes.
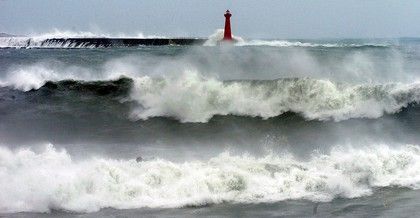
[131,72,420,122]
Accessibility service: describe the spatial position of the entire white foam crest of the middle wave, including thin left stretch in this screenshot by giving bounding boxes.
[0,61,420,122]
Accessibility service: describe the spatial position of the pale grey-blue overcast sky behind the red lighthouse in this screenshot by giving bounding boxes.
[0,0,420,38]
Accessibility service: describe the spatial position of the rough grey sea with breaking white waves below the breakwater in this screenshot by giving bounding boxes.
[0,38,420,217]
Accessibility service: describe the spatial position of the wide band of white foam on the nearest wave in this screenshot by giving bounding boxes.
[0,145,420,213]
